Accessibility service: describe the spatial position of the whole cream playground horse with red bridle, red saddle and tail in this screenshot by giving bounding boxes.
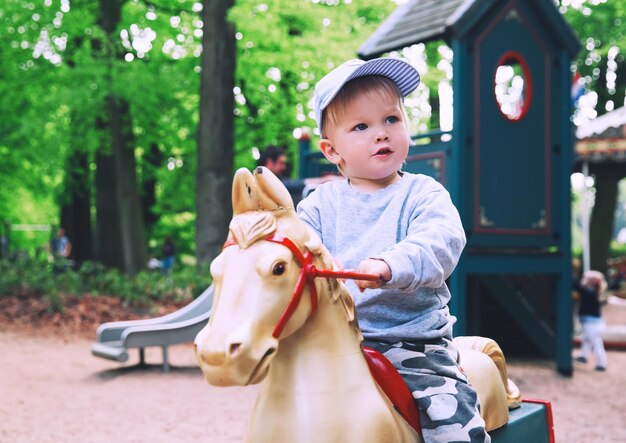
[195,168,519,443]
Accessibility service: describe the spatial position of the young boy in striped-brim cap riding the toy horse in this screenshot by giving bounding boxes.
[298,59,490,442]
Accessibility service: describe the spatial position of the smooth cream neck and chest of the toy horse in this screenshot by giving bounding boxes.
[248,288,421,443]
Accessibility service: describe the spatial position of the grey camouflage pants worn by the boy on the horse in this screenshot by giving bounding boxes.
[363,339,491,443]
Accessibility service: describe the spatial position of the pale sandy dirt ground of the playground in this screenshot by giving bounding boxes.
[0,294,626,443]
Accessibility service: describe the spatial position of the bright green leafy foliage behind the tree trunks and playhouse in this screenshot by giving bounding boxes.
[0,0,626,262]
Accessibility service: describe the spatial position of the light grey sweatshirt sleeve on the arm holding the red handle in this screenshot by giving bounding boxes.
[372,187,466,292]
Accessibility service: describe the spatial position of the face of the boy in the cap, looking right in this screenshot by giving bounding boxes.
[320,89,409,187]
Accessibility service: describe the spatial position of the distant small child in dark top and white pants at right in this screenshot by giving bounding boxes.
[574,271,607,371]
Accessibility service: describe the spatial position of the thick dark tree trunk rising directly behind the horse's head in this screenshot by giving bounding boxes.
[196,0,236,263]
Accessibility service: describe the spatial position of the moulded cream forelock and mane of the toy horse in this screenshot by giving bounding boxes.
[229,210,362,339]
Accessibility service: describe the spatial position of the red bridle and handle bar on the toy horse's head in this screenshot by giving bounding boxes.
[222,234,381,338]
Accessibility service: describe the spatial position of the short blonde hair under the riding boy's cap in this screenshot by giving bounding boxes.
[321,75,408,138]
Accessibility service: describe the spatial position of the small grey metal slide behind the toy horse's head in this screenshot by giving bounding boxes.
[91,285,213,371]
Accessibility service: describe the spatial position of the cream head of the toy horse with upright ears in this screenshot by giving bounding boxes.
[195,167,355,386]
